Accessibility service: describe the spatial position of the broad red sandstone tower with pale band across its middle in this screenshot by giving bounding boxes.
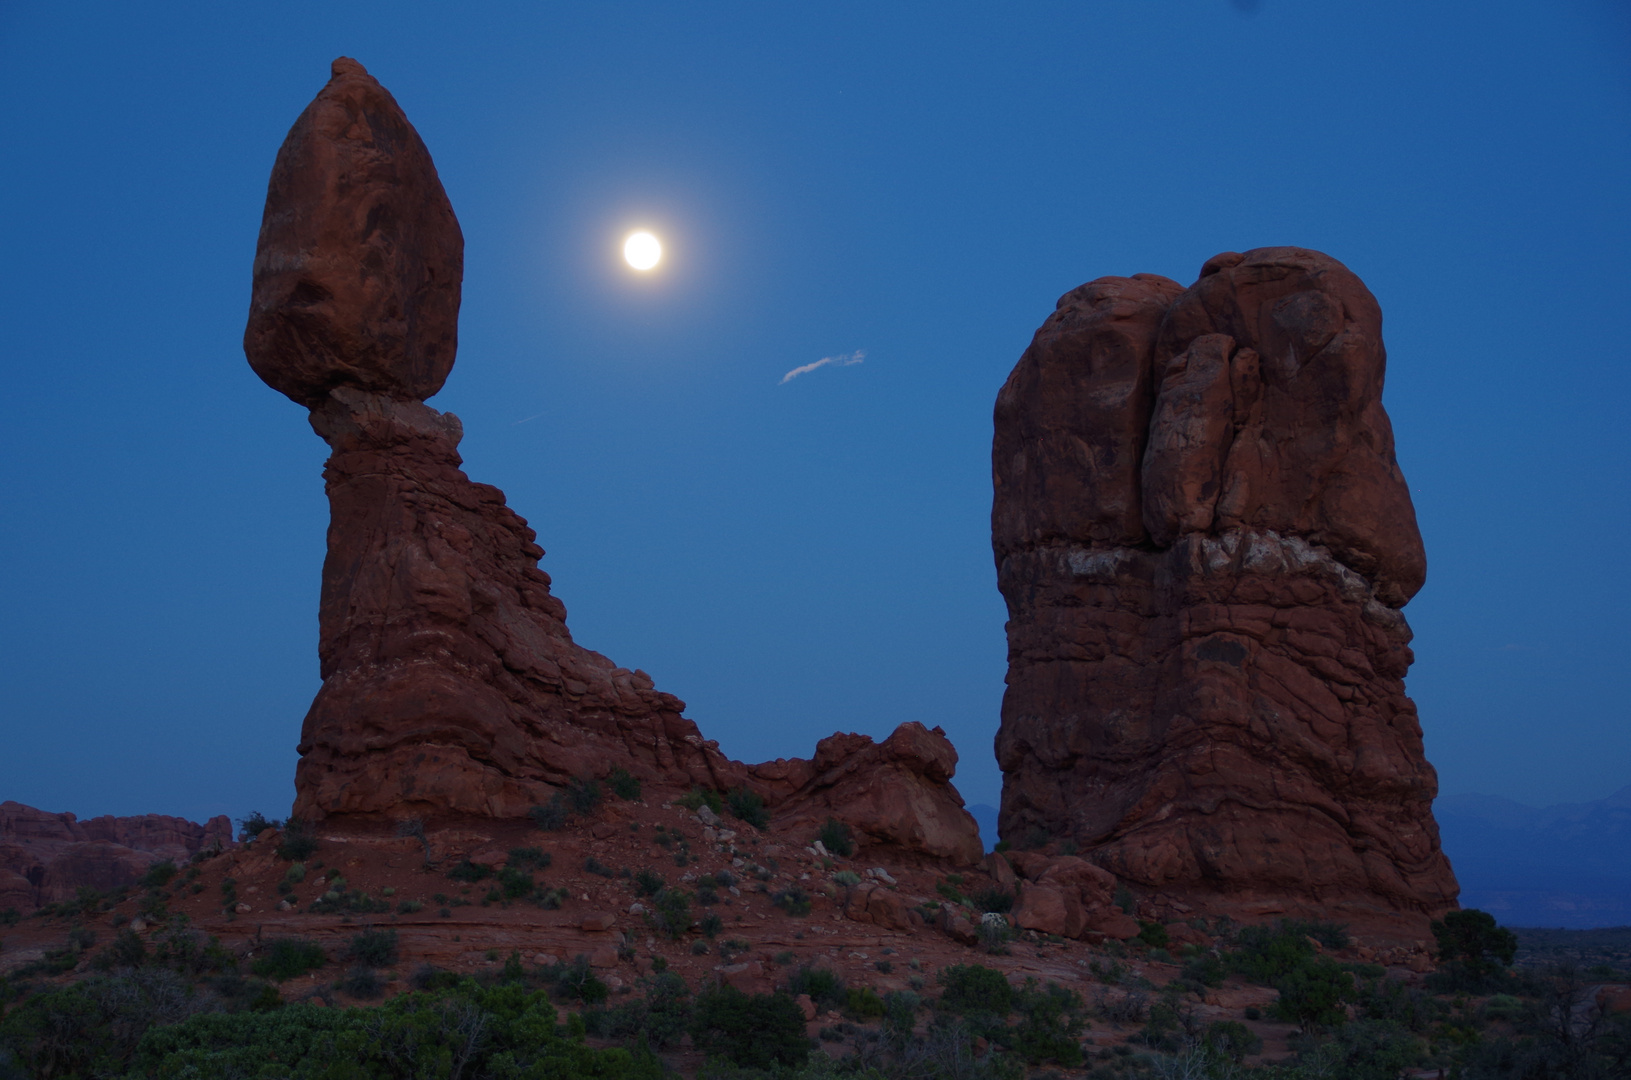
[992,248,1456,936]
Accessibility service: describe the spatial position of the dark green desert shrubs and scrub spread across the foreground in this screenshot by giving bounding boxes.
[0,894,1631,1080]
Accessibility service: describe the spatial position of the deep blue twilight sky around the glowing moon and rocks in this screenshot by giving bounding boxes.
[0,0,1631,828]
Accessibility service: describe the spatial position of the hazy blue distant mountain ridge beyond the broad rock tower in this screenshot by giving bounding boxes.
[1434,786,1631,928]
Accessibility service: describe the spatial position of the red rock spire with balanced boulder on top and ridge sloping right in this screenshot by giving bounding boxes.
[245,59,980,861]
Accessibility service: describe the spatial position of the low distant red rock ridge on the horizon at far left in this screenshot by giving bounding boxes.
[0,801,232,910]
